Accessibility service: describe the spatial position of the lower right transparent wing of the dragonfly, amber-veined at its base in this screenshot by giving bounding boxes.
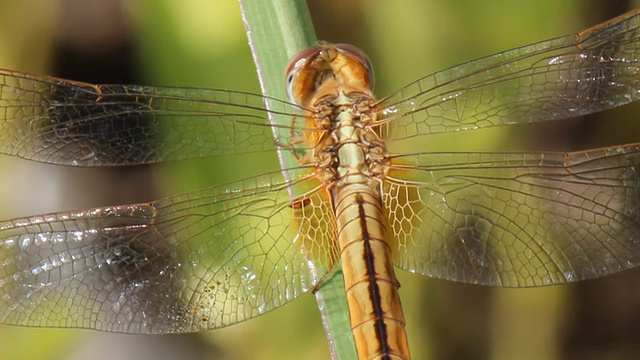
[383,144,640,287]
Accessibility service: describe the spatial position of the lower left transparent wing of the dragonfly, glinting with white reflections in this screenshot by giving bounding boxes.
[0,173,337,333]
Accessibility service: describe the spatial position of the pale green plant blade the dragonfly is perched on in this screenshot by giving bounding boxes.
[240,0,356,360]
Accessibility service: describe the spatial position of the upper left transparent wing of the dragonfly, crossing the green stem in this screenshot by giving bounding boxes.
[0,69,298,166]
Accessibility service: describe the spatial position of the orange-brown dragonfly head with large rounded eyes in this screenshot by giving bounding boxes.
[285,43,373,106]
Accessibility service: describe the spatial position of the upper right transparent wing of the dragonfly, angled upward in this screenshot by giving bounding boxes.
[380,10,640,140]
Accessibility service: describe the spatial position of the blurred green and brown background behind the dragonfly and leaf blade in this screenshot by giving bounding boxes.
[0,0,640,359]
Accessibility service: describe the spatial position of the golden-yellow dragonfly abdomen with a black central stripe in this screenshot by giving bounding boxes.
[335,184,409,359]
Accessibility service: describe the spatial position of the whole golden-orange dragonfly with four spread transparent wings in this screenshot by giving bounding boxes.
[0,6,640,359]
